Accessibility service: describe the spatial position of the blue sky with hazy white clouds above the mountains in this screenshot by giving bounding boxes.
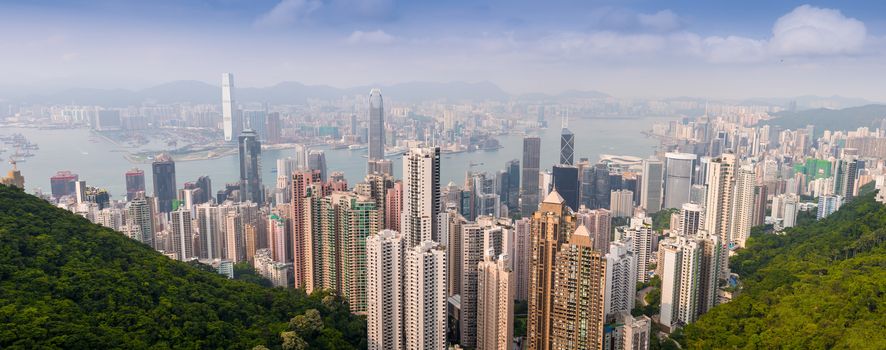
[0,0,886,101]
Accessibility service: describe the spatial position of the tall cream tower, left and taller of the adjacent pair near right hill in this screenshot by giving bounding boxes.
[704,153,737,278]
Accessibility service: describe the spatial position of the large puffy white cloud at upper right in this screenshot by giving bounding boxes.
[769,5,867,56]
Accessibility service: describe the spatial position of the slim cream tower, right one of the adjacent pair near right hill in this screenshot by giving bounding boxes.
[726,165,757,248]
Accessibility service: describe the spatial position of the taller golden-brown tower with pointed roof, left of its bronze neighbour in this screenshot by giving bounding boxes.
[526,190,576,350]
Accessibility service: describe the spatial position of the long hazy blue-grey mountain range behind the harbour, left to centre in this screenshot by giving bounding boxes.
[6,80,512,107]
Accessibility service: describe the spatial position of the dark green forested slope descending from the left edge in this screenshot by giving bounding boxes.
[0,185,366,349]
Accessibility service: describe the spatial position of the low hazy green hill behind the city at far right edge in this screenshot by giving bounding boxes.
[764,105,886,134]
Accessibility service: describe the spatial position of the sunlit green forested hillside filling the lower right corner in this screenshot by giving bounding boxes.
[678,193,886,349]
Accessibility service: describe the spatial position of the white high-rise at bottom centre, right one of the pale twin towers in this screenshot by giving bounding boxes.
[403,241,447,350]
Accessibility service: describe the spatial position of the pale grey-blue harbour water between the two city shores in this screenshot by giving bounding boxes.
[0,118,664,199]
